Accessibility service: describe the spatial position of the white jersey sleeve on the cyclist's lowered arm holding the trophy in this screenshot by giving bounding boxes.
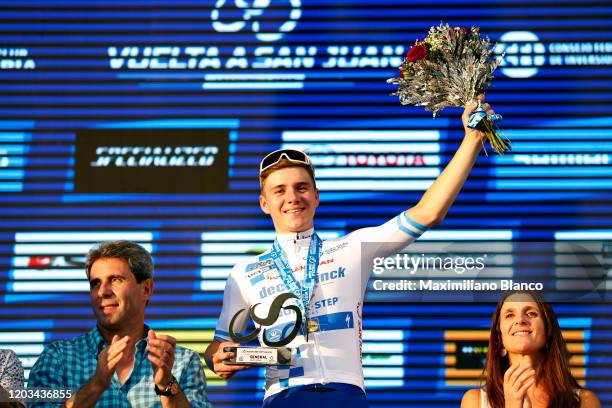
[214,264,250,342]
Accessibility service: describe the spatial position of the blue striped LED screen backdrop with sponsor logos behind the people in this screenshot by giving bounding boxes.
[0,0,612,407]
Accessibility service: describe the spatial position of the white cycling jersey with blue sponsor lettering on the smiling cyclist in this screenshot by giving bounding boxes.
[215,212,425,398]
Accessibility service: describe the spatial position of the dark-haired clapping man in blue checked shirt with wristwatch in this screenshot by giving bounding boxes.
[28,241,210,408]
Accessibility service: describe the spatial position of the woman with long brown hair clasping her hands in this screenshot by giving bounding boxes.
[461,292,600,408]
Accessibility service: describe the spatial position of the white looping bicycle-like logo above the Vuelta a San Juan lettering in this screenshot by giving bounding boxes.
[210,0,302,42]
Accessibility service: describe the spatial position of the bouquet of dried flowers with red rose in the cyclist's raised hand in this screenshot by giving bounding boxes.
[387,23,510,155]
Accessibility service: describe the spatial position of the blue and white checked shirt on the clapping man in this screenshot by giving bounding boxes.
[28,326,211,408]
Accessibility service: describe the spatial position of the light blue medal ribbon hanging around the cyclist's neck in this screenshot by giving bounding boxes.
[270,233,323,341]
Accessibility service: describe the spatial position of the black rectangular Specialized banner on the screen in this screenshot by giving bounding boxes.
[75,129,229,193]
